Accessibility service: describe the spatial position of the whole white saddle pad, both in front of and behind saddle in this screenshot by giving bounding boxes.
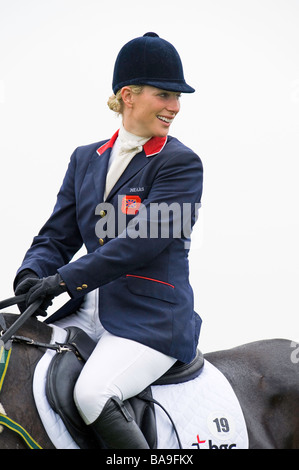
[33,325,248,449]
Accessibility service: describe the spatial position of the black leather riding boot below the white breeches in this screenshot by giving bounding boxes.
[89,397,149,449]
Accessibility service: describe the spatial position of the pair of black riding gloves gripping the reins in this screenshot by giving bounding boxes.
[15,273,67,316]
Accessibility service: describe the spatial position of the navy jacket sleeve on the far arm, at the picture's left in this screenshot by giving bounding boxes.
[17,151,83,277]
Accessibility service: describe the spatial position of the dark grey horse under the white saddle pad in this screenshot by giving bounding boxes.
[0,314,299,449]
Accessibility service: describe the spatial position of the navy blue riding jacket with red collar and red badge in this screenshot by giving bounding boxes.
[18,133,202,362]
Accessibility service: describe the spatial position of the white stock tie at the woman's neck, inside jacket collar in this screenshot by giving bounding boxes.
[104,125,150,201]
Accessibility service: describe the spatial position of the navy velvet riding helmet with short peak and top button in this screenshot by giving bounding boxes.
[112,33,195,94]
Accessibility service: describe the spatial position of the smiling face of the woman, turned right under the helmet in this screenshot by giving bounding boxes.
[122,85,180,137]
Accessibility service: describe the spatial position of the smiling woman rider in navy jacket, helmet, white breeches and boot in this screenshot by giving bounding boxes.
[14,33,202,449]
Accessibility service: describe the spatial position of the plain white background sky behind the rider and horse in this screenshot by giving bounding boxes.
[0,0,299,352]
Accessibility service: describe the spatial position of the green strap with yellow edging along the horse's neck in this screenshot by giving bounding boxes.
[0,346,41,449]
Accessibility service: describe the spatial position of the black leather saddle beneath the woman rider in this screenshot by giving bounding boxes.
[46,327,204,449]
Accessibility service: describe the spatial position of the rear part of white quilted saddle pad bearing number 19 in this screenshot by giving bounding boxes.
[152,360,248,449]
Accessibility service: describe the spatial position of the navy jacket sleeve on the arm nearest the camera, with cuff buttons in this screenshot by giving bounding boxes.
[58,148,203,298]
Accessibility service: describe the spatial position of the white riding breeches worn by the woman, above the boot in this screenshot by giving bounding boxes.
[55,290,176,424]
